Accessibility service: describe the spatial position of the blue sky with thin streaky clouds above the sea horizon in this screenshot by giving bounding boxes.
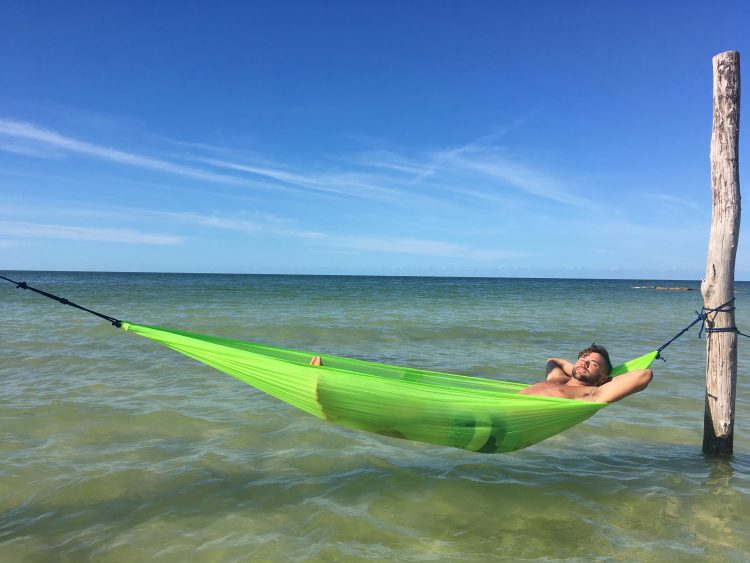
[0,0,750,280]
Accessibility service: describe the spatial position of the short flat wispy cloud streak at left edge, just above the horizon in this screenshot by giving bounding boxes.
[0,221,186,245]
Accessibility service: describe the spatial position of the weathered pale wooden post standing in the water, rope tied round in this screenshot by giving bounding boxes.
[701,51,740,455]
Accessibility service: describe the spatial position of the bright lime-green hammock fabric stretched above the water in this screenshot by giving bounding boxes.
[122,322,658,453]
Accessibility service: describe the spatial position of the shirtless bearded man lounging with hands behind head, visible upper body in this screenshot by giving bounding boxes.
[519,344,654,403]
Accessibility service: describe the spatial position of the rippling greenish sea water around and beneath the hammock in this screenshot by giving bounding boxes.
[0,272,750,562]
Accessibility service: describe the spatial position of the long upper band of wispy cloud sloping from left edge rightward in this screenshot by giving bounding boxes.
[0,119,596,213]
